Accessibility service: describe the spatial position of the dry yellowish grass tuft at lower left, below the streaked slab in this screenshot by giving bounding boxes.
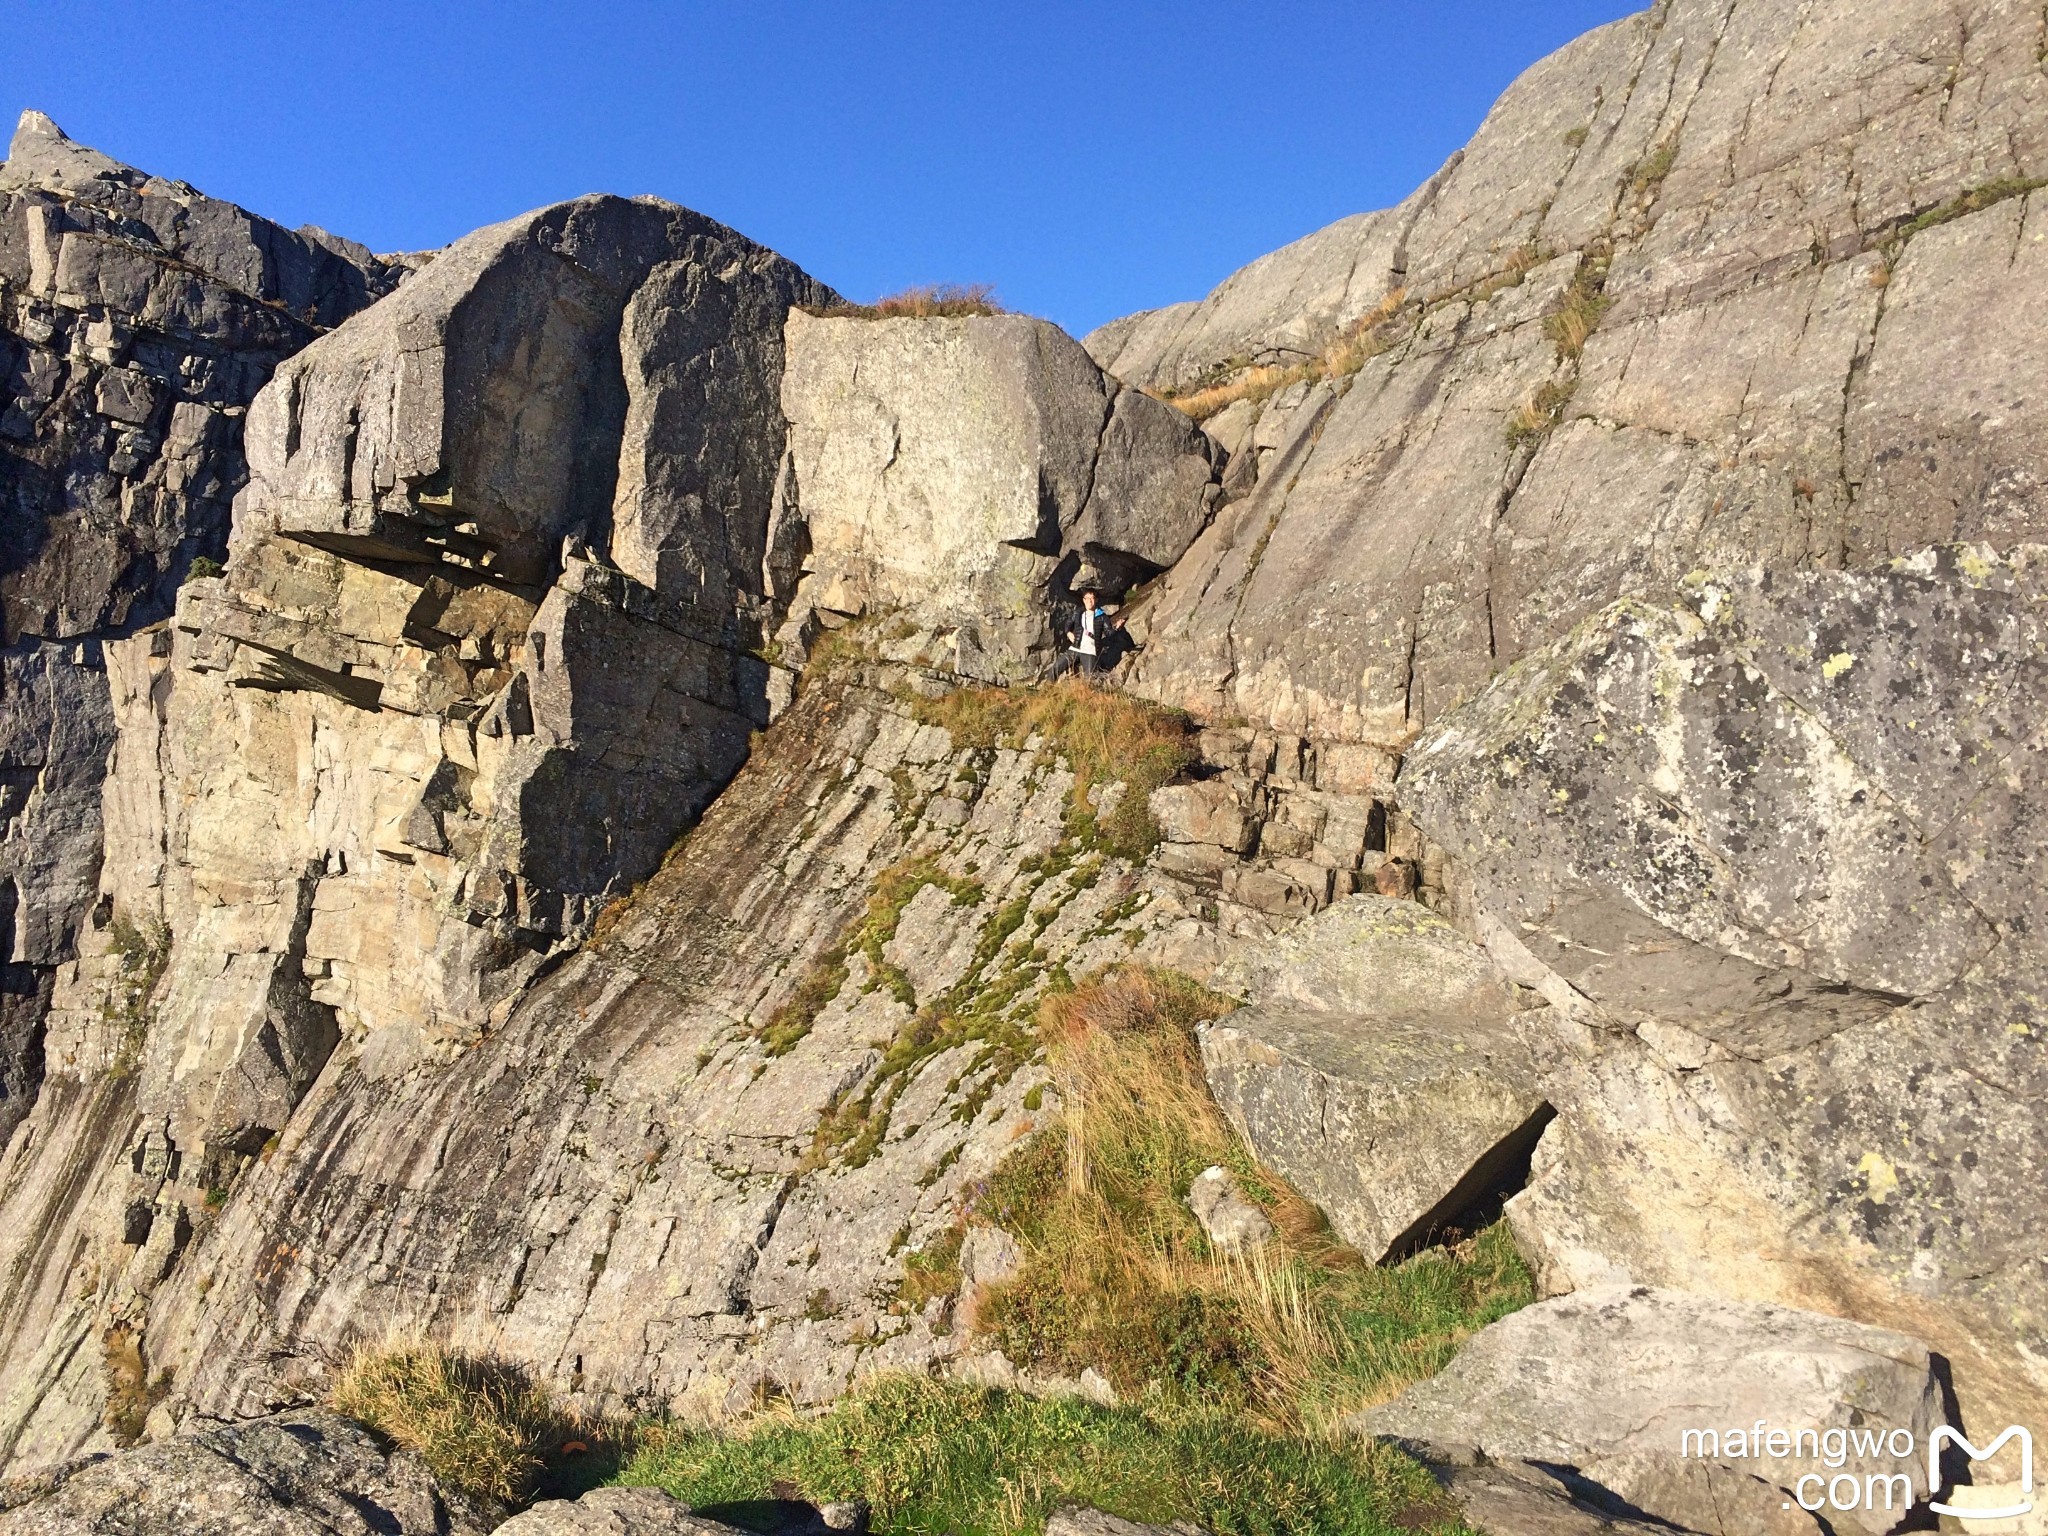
[328,1333,594,1507]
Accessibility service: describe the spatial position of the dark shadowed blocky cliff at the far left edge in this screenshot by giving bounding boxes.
[0,113,403,1139]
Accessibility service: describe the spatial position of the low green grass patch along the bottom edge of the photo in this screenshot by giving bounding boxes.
[618,1376,1460,1536]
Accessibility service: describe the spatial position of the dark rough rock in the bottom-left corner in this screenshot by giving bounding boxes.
[0,1411,487,1536]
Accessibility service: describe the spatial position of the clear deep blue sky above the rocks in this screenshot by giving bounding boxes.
[0,0,1645,332]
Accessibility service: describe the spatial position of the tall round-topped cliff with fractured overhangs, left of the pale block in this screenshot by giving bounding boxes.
[0,189,834,1466]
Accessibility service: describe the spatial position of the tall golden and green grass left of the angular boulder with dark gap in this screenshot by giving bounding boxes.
[969,967,1534,1436]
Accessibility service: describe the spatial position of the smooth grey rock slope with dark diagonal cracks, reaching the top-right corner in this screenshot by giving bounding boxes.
[1090,0,2048,748]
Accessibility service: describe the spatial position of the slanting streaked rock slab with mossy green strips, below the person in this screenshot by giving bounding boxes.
[75,668,1192,1448]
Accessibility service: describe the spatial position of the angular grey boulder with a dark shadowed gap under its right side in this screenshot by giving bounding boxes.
[1200,897,1550,1262]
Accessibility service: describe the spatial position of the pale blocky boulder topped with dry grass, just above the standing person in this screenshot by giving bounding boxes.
[772,311,1221,680]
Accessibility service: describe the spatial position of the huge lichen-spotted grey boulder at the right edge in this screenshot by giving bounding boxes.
[1401,547,2048,1423]
